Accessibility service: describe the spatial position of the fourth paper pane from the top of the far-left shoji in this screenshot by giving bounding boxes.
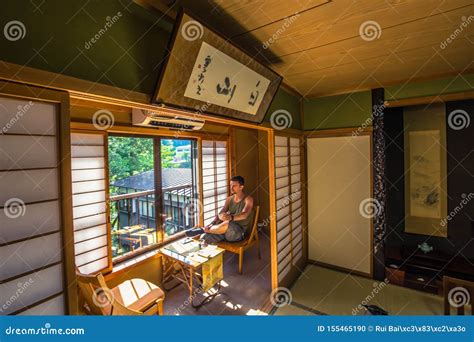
[0,201,60,243]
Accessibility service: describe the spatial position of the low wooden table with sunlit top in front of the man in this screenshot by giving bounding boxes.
[159,238,225,308]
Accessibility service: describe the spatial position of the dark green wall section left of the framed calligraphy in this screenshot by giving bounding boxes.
[0,0,172,94]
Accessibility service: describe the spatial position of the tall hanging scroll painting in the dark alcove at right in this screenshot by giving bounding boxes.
[403,104,447,237]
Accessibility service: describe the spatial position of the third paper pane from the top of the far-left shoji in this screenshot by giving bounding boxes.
[0,169,58,206]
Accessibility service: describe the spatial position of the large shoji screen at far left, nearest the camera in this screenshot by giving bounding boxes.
[0,91,71,315]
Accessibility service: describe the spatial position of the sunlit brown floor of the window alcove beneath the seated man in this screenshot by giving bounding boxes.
[164,233,271,315]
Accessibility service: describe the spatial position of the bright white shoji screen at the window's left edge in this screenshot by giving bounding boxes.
[71,132,112,274]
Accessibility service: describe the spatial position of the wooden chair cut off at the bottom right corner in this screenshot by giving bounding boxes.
[443,276,474,315]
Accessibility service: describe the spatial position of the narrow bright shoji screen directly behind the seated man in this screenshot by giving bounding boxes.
[201,140,229,225]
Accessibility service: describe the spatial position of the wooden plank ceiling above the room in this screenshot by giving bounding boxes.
[164,0,474,98]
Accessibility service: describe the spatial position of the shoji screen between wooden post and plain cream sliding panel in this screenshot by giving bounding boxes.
[275,136,304,283]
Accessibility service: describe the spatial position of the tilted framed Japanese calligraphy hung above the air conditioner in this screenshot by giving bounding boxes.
[152,13,282,123]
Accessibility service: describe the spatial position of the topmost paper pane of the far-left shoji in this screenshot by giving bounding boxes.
[0,97,56,135]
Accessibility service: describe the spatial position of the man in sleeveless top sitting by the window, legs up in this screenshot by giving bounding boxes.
[186,176,253,243]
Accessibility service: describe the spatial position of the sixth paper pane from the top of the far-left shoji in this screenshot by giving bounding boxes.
[0,264,63,315]
